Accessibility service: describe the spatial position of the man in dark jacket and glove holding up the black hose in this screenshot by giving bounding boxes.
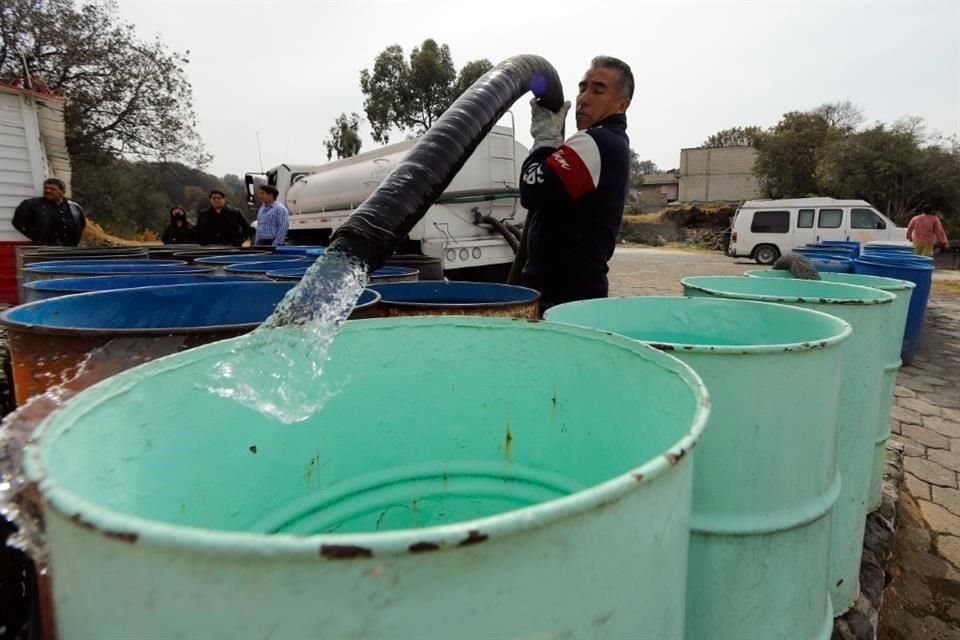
[520,56,634,312]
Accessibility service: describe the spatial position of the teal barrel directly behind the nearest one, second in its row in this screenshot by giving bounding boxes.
[545,296,851,640]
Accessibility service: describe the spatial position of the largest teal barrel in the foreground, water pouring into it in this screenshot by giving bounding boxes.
[25,317,709,640]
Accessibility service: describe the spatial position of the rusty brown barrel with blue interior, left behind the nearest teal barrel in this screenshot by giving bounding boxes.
[0,282,380,405]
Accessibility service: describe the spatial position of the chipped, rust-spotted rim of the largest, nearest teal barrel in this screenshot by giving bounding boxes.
[24,317,710,561]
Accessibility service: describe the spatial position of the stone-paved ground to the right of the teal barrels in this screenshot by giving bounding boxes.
[879,294,960,640]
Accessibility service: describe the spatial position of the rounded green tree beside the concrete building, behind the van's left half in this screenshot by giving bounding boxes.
[753,111,842,198]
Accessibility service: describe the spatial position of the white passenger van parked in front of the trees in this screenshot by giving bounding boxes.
[727,198,907,264]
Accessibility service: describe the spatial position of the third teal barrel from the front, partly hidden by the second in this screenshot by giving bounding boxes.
[681,276,896,615]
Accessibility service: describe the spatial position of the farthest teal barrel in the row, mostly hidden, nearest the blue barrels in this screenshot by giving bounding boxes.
[744,269,917,512]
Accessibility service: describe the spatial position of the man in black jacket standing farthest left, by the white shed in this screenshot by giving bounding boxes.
[13,178,87,247]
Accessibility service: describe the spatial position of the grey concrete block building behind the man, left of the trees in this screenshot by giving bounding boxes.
[679,147,759,202]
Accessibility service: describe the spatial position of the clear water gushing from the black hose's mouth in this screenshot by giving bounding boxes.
[204,253,366,424]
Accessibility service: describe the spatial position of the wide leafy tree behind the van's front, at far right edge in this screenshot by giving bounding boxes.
[817,118,960,223]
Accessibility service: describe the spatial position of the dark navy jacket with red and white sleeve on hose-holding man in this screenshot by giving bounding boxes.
[520,114,630,307]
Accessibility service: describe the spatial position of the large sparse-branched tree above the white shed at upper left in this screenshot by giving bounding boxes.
[0,0,209,166]
